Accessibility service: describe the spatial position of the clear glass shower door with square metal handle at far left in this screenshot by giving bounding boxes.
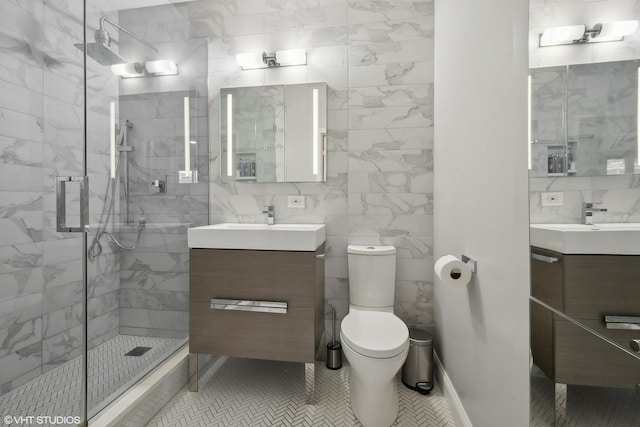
[0,0,86,425]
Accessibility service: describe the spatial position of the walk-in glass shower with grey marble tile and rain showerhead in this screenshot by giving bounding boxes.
[0,0,209,425]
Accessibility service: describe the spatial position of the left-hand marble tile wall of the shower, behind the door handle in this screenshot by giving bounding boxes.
[0,1,118,392]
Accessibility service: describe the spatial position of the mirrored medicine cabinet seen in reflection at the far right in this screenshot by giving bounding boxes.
[529,60,640,177]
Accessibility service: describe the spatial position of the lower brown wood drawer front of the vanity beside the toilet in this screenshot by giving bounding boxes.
[189,301,316,363]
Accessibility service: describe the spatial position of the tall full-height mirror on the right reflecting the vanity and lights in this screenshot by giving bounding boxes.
[527,0,640,427]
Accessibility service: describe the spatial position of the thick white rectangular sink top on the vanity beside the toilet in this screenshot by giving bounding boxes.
[187,223,326,251]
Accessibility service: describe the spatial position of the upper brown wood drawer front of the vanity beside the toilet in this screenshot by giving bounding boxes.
[189,249,316,307]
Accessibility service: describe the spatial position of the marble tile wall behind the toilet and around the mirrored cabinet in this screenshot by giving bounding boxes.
[188,0,433,336]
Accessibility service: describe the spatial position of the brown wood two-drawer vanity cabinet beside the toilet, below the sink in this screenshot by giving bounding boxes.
[189,245,324,363]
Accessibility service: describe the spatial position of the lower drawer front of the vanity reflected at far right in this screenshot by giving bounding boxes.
[554,320,640,388]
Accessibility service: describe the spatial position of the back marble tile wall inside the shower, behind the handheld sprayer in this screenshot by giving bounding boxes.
[114,5,209,338]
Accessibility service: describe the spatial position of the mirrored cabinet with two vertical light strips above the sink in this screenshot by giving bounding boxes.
[220,83,327,182]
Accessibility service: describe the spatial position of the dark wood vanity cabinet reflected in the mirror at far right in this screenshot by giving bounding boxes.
[531,247,640,388]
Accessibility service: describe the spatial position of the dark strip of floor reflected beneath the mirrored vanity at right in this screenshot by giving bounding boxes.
[530,368,640,427]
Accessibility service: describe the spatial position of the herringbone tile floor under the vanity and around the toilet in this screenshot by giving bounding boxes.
[147,357,455,427]
